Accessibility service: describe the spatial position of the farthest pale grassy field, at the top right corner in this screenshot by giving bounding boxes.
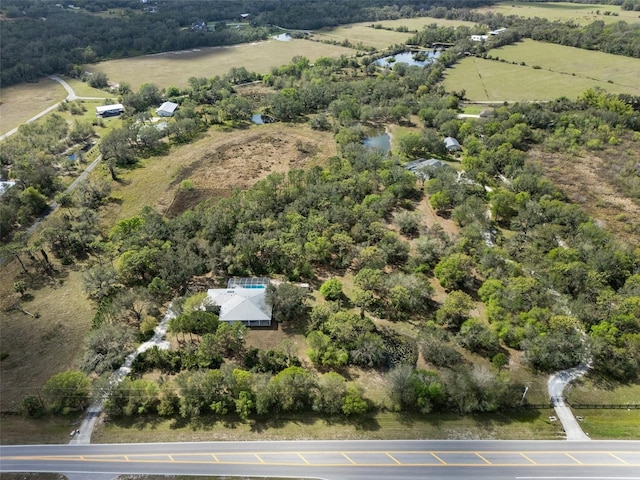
[477,2,640,25]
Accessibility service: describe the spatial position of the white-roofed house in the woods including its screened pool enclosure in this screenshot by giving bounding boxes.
[205,277,272,327]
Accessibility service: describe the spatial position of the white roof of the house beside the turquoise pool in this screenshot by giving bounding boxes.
[207,287,272,322]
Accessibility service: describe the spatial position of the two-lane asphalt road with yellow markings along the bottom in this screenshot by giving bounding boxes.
[0,440,640,480]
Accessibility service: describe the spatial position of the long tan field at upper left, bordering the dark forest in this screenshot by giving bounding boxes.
[86,39,355,90]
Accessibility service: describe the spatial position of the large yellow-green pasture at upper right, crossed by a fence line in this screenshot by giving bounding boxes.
[444,40,640,101]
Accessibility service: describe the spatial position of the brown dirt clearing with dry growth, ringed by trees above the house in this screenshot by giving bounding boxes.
[165,124,336,216]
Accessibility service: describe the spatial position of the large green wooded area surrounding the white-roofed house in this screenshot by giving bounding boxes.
[0,0,640,428]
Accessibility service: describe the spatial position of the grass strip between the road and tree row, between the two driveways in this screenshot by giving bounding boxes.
[86,410,562,443]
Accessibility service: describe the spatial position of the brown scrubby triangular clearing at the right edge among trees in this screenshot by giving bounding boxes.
[530,145,640,245]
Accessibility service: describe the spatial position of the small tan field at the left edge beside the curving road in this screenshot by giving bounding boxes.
[0,78,67,135]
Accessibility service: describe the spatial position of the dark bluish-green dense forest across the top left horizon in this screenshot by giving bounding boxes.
[0,0,496,86]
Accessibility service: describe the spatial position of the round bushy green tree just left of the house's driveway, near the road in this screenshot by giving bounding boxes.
[44,370,91,414]
